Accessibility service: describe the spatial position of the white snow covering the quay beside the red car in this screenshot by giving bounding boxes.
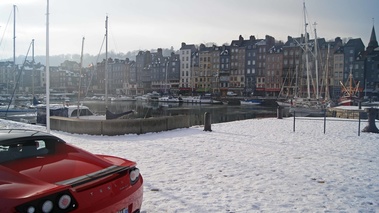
[0,118,379,213]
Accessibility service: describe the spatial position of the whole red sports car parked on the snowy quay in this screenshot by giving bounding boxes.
[0,129,143,213]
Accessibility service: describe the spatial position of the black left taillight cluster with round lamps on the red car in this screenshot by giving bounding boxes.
[16,191,78,213]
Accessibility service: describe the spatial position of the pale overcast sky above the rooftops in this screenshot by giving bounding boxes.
[0,0,379,60]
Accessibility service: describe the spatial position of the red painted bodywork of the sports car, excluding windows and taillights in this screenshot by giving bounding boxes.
[0,129,143,213]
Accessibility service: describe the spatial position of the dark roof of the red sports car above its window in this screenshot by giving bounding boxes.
[0,129,56,144]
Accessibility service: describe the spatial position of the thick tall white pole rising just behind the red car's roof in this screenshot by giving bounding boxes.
[46,0,50,133]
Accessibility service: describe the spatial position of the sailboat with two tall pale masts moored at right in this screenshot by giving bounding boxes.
[289,2,325,117]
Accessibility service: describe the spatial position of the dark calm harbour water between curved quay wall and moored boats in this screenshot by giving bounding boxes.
[84,101,276,126]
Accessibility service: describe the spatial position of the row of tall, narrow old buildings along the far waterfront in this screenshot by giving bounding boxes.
[0,27,379,98]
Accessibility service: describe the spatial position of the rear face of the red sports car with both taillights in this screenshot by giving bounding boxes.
[16,162,143,213]
